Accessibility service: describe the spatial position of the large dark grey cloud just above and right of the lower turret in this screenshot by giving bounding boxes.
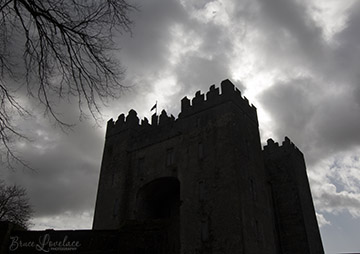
[259,76,360,166]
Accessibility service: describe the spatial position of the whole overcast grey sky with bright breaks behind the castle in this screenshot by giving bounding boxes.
[1,0,360,253]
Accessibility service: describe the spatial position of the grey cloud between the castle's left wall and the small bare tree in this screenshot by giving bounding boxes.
[2,118,103,217]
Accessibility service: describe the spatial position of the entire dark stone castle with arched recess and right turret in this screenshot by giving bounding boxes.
[93,80,324,254]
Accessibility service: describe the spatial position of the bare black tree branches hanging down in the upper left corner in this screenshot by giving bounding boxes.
[0,0,136,167]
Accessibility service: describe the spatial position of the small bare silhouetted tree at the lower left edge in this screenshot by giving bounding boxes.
[0,182,33,228]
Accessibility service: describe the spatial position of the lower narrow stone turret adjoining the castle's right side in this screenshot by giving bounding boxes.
[264,137,324,254]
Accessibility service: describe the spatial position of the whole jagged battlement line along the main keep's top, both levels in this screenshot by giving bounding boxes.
[106,79,258,137]
